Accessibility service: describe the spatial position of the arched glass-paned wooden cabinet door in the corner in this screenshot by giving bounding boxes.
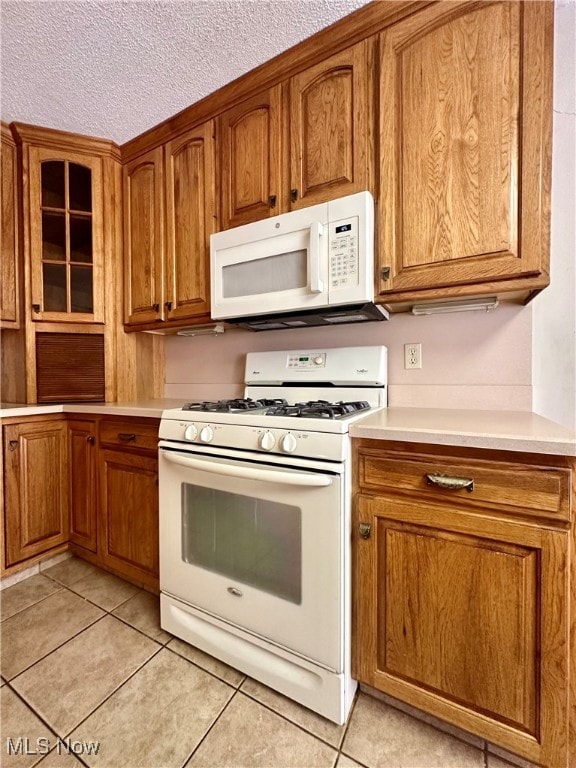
[28,146,104,323]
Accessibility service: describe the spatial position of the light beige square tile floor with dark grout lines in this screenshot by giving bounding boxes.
[0,558,528,768]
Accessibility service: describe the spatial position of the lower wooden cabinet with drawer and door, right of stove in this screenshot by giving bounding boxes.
[353,440,574,768]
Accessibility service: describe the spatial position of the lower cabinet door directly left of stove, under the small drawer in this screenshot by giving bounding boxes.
[99,450,159,589]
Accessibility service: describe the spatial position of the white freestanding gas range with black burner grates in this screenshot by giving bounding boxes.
[159,347,387,723]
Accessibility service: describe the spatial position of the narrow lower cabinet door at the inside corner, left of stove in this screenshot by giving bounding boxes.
[68,419,97,552]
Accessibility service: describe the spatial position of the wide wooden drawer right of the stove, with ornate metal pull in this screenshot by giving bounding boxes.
[358,448,571,521]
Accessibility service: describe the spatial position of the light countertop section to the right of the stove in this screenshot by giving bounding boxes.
[350,408,576,456]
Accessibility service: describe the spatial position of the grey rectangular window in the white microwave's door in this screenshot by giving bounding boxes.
[222,249,308,299]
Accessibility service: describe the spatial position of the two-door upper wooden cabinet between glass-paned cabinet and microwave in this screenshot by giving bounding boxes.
[124,121,216,329]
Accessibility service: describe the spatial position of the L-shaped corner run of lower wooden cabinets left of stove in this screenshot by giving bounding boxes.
[2,414,159,591]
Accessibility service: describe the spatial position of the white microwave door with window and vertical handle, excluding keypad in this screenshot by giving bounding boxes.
[212,220,328,320]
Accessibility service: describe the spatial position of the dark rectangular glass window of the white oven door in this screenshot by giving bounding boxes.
[182,483,302,604]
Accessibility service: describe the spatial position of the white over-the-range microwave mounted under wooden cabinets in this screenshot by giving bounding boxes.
[210,192,388,330]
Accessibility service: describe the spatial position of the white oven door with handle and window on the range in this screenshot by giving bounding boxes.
[159,448,348,671]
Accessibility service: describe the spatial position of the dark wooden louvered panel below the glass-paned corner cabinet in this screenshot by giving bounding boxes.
[36,333,105,403]
